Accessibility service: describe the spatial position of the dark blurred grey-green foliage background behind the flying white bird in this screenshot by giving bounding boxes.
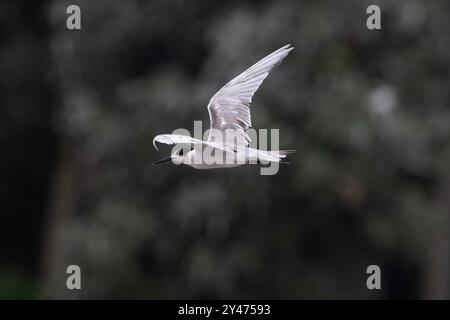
[0,0,450,299]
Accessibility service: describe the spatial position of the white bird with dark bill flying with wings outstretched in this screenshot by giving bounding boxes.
[153,44,294,169]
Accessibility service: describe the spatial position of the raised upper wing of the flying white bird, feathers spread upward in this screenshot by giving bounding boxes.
[208,44,294,145]
